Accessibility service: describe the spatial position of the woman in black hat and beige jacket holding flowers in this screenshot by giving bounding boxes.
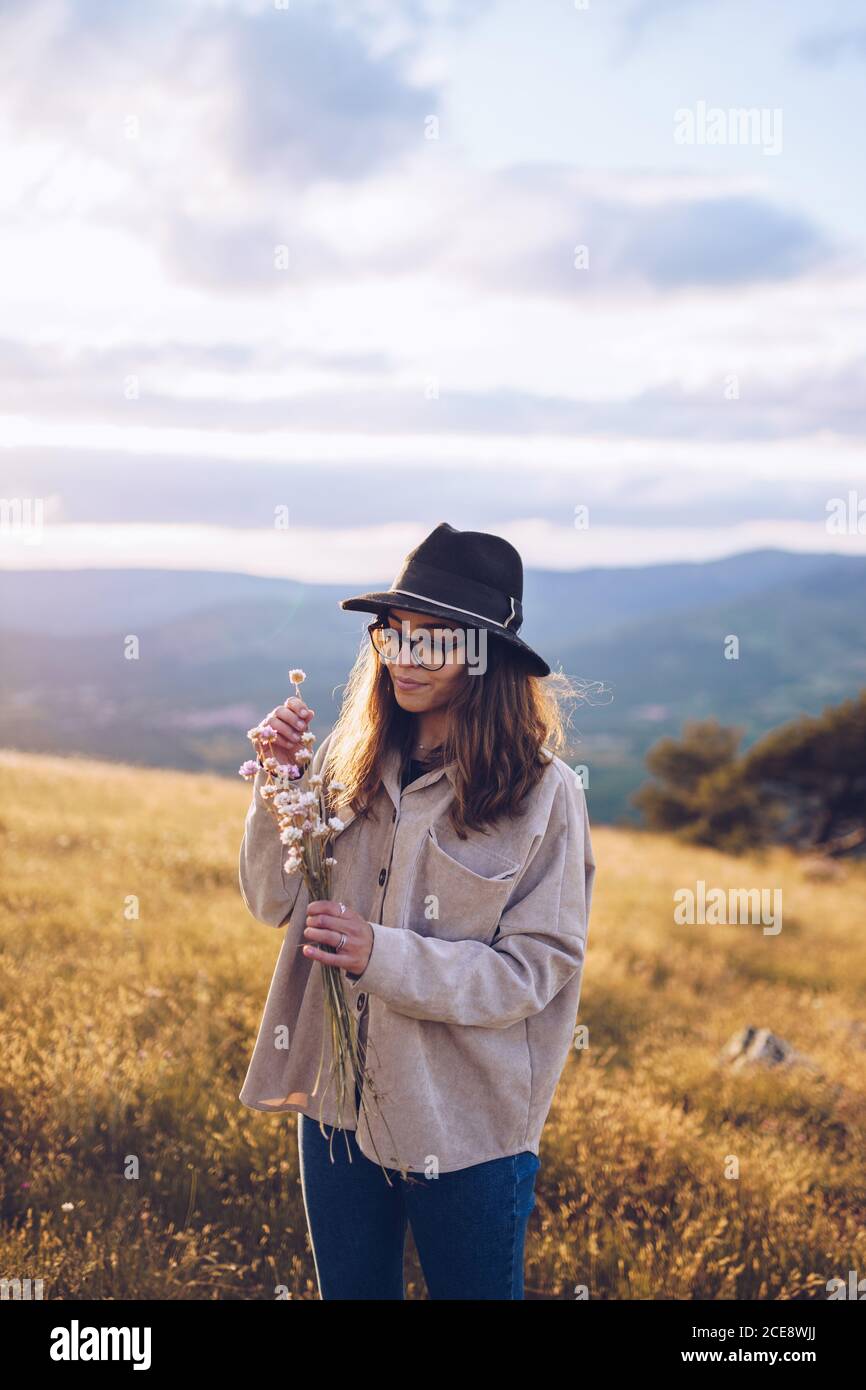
[239,523,595,1300]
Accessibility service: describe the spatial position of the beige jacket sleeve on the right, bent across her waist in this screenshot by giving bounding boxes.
[353,773,595,1029]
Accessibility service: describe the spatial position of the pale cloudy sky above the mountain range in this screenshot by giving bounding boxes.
[0,0,866,581]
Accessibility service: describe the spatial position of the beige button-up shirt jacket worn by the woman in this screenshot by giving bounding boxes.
[239,735,595,1173]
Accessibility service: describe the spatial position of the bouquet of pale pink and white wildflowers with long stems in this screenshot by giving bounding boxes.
[239,669,405,1182]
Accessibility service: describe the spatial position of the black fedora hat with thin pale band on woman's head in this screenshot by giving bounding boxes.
[339,521,550,676]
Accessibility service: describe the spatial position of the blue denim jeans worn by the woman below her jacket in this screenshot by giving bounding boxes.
[297,1115,539,1300]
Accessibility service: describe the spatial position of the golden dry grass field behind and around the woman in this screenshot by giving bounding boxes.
[0,749,866,1300]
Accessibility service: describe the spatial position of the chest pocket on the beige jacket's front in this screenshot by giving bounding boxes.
[403,827,520,945]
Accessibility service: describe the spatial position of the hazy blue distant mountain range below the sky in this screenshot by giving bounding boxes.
[0,550,866,821]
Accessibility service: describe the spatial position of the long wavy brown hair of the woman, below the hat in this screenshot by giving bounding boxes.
[322,635,589,840]
